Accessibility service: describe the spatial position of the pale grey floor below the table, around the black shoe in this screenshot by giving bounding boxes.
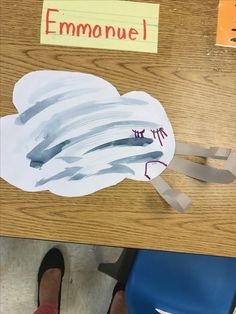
[0,238,121,314]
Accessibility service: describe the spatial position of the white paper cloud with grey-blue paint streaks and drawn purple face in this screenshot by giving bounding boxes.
[1,71,175,196]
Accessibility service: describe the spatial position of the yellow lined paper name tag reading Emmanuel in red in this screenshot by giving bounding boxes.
[40,0,159,53]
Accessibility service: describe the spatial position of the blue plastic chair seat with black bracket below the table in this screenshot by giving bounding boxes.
[100,250,236,314]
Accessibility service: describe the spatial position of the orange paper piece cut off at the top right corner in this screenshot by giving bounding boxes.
[216,0,236,47]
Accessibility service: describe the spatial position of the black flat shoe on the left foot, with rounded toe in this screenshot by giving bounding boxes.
[38,248,65,313]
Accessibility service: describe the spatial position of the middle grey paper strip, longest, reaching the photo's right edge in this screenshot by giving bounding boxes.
[168,153,236,184]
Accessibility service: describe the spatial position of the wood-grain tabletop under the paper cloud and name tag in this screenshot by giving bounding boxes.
[0,0,236,256]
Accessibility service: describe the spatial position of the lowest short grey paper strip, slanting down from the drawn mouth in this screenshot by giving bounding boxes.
[150,176,192,213]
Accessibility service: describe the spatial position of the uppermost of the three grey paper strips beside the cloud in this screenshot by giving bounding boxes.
[175,142,231,160]
